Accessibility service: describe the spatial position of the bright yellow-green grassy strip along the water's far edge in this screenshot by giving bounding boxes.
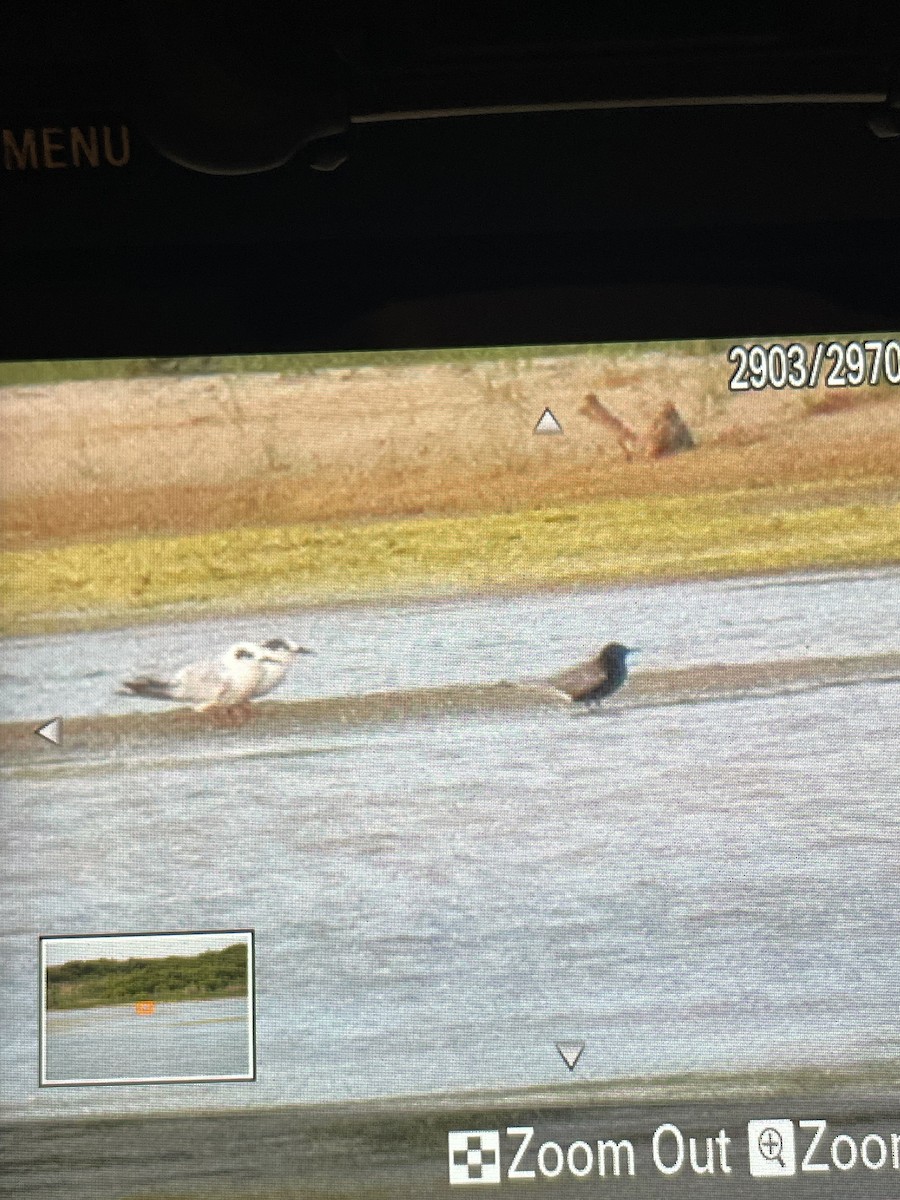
[0,486,900,634]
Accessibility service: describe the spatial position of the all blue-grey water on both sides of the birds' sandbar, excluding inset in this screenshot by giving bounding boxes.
[0,571,900,1115]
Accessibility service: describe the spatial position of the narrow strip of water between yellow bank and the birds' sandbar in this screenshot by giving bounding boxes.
[0,569,900,721]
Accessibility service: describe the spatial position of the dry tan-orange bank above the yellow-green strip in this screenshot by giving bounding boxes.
[0,354,900,547]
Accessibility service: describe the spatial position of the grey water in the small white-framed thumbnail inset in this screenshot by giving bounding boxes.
[44,1000,253,1084]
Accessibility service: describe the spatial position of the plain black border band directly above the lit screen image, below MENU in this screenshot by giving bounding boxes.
[0,221,900,361]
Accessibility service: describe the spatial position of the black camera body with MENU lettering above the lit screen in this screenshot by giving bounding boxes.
[0,4,900,359]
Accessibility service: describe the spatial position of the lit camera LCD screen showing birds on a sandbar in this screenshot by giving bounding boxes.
[0,331,900,1200]
